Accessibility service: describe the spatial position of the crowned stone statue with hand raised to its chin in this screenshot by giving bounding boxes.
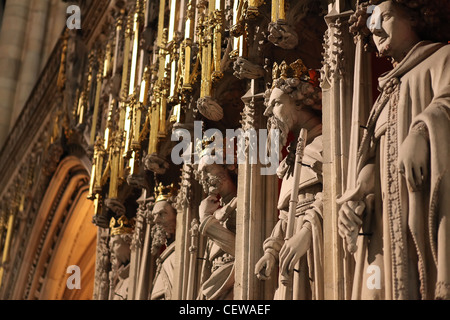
[195,136,237,300]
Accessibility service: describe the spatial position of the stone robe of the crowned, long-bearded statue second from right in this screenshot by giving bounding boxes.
[263,136,324,300]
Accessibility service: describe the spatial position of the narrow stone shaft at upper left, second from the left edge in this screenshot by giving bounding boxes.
[10,0,50,128]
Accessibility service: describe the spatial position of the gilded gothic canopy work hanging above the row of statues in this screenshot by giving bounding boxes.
[83,0,285,206]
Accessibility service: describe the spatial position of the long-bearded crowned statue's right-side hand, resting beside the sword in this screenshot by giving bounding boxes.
[280,228,311,276]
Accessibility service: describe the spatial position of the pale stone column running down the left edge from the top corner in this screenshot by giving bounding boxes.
[0,0,31,146]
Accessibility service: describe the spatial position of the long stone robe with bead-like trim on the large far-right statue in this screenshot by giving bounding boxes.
[352,41,450,299]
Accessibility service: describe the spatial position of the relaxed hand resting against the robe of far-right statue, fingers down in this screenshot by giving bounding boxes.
[398,131,430,192]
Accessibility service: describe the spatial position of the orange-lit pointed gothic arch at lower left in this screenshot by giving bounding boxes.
[14,156,97,300]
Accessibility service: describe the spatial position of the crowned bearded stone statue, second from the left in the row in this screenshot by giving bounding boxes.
[150,184,177,300]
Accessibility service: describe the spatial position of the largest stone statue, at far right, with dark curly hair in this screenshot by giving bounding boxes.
[338,1,450,299]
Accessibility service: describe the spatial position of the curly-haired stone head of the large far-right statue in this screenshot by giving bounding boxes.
[349,0,450,53]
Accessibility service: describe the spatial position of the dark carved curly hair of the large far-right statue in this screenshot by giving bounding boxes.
[349,0,450,51]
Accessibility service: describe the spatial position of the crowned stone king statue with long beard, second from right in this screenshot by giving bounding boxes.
[255,60,323,300]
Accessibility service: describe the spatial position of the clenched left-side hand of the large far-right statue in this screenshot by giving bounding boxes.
[338,201,366,253]
